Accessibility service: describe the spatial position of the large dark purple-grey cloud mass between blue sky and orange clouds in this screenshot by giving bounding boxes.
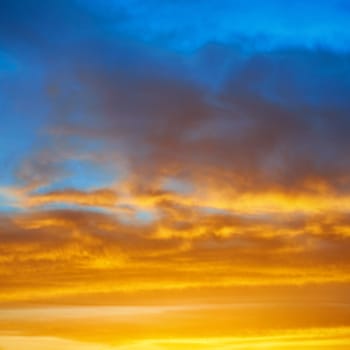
[40,43,349,197]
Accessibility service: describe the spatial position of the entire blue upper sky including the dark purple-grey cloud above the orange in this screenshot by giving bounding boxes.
[0,0,350,194]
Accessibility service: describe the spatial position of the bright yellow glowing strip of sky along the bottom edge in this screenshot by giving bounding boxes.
[0,304,350,350]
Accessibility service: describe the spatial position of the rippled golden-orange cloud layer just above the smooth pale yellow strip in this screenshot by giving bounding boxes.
[0,207,350,302]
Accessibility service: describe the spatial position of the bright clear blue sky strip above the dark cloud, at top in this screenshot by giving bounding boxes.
[81,0,349,51]
